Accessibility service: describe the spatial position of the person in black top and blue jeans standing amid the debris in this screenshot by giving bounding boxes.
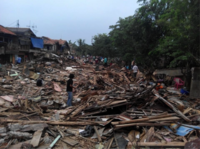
[67,74,75,107]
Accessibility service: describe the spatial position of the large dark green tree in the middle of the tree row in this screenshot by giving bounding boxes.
[109,3,166,69]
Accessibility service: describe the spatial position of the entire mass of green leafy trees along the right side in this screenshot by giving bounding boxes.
[70,0,200,69]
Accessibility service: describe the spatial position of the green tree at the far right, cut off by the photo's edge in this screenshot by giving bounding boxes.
[138,0,200,88]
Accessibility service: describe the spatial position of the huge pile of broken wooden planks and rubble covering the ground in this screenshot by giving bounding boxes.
[0,53,200,149]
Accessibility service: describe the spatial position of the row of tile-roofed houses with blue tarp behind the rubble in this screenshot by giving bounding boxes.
[0,25,70,64]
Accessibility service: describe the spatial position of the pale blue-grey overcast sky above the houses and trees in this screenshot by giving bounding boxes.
[0,0,139,44]
